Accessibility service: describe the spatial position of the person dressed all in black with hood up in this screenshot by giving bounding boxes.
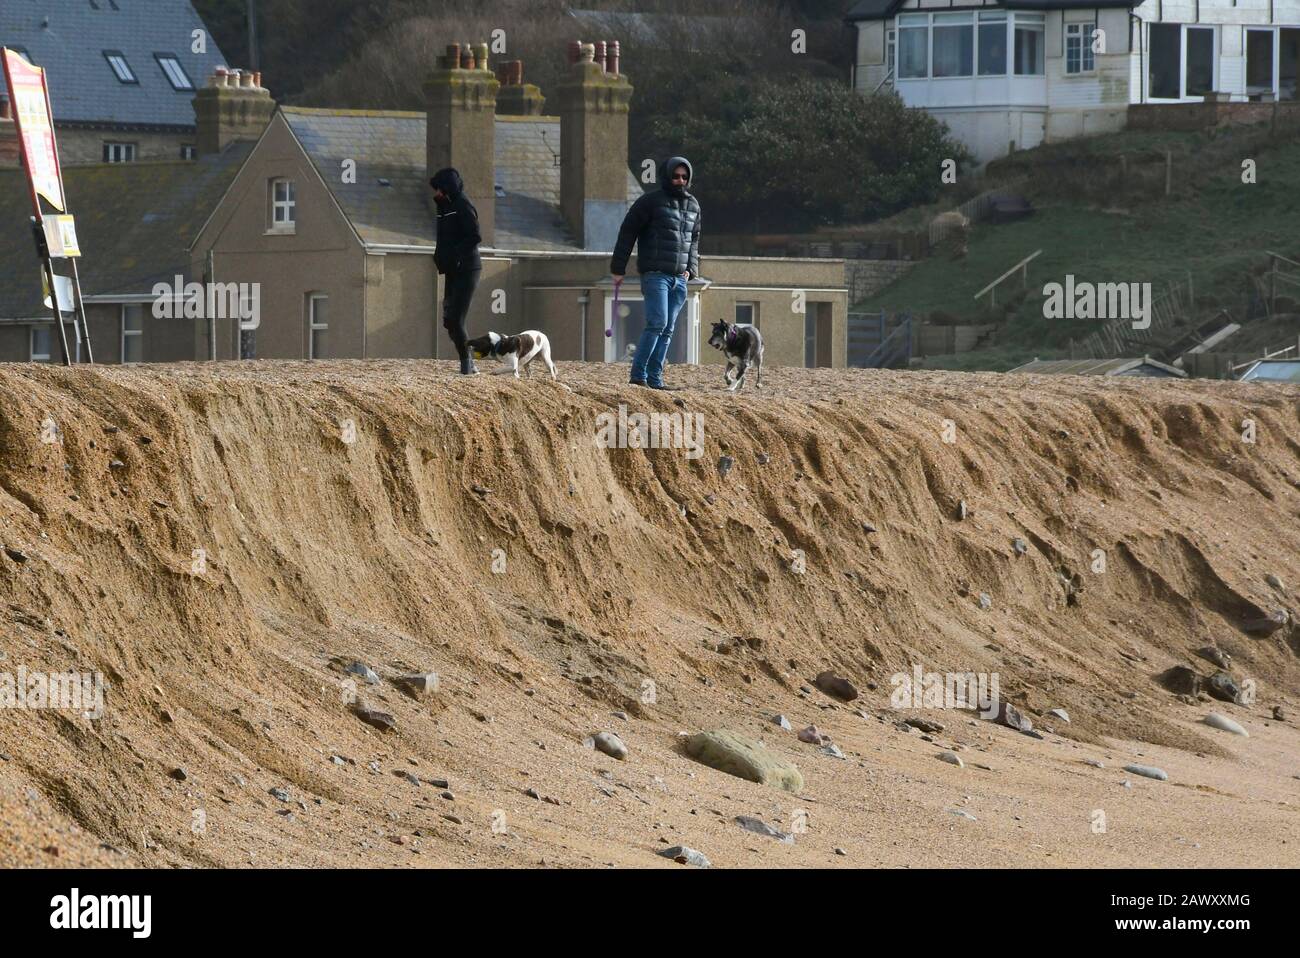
[429,168,484,376]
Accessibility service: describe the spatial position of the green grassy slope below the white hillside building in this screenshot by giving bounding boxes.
[854,134,1300,369]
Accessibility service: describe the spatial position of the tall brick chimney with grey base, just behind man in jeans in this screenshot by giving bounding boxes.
[558,40,632,250]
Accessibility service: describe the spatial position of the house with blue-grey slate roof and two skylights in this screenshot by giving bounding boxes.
[0,0,226,166]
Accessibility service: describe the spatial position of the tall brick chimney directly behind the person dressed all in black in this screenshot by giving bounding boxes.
[424,43,501,246]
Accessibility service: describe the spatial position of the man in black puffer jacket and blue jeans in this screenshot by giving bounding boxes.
[610,156,699,389]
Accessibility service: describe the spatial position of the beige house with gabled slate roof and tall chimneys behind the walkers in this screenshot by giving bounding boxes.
[188,43,848,365]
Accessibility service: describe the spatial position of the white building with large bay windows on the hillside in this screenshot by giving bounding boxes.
[848,0,1300,162]
